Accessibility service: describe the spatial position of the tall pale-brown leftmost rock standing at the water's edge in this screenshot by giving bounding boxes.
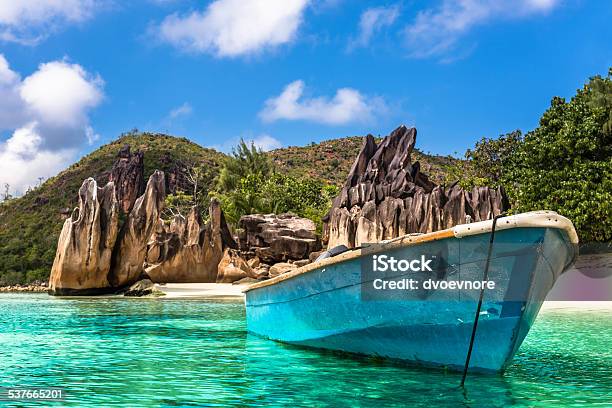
[49,178,119,295]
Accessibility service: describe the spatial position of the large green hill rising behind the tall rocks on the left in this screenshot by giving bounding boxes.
[0,133,224,285]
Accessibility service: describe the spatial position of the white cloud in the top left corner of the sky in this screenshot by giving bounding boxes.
[0,0,101,45]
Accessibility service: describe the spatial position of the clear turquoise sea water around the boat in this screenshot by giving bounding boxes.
[0,294,612,407]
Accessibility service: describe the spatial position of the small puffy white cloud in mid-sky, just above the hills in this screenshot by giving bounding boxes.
[259,80,386,125]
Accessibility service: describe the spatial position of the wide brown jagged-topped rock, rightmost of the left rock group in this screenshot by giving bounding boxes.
[146,200,238,283]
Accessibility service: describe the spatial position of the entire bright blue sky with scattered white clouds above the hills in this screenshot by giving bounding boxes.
[0,0,612,192]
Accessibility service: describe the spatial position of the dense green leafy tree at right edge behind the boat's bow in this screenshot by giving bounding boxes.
[502,75,612,241]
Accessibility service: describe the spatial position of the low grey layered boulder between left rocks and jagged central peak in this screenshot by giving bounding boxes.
[238,214,321,263]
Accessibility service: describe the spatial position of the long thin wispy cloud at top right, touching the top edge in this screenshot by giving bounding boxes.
[405,0,559,58]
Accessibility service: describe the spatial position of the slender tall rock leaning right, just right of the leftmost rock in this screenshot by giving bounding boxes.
[109,171,166,287]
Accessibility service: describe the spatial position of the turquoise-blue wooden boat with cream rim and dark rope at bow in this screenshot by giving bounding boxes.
[245,211,578,372]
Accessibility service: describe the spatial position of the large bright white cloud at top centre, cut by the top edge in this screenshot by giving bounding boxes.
[158,0,309,57]
